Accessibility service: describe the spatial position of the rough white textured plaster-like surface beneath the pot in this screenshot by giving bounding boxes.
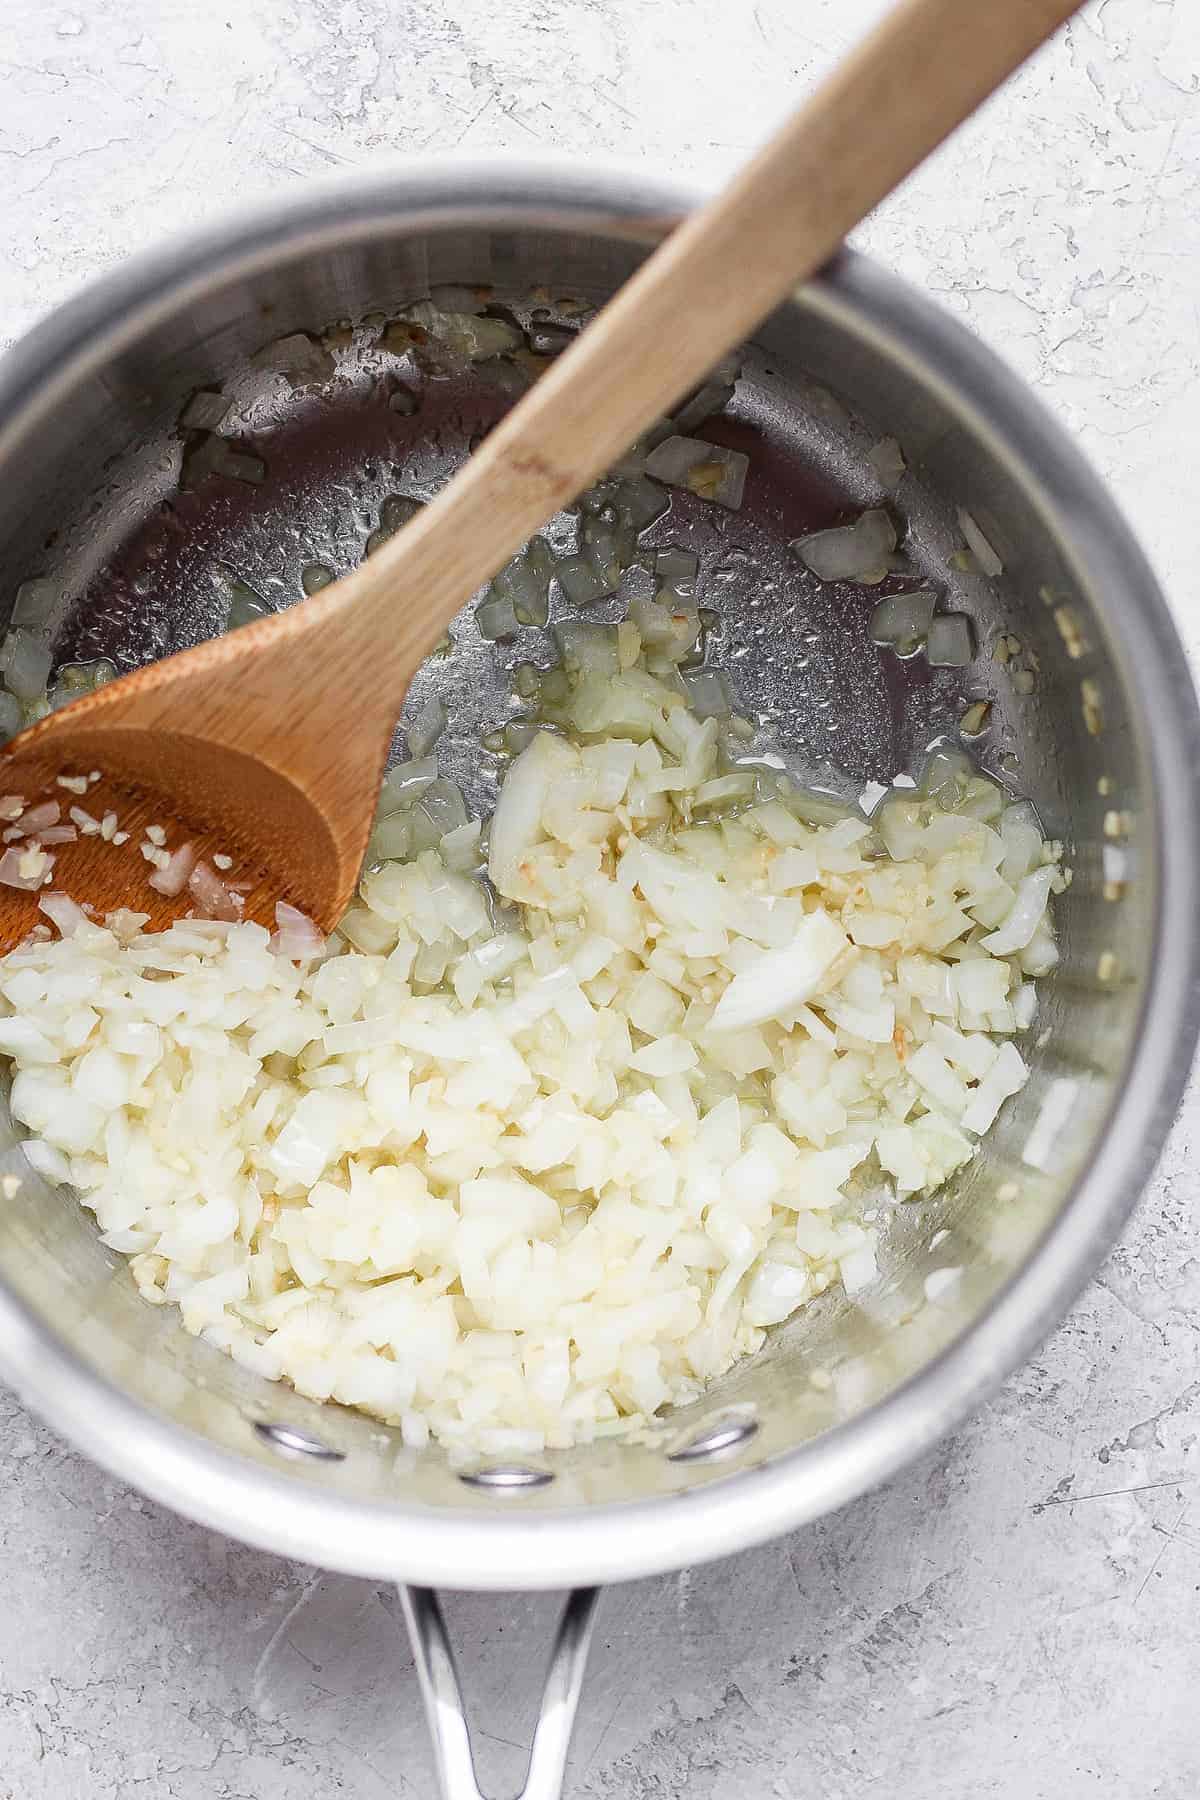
[0,0,1200,1800]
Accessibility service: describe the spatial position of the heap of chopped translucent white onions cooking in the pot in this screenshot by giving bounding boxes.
[0,464,1067,1454]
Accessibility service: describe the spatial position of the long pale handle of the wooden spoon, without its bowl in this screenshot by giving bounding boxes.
[332,0,1081,666]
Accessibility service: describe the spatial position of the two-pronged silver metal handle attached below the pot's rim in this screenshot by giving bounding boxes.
[396,1582,599,1800]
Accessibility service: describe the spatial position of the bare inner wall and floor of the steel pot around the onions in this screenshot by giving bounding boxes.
[0,207,1155,1512]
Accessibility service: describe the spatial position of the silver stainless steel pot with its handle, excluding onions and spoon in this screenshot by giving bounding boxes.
[0,164,1200,1795]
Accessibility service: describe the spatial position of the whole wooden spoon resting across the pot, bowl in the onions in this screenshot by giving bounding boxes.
[0,0,1079,945]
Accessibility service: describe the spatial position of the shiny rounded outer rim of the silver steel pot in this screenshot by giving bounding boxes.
[0,157,1200,1589]
